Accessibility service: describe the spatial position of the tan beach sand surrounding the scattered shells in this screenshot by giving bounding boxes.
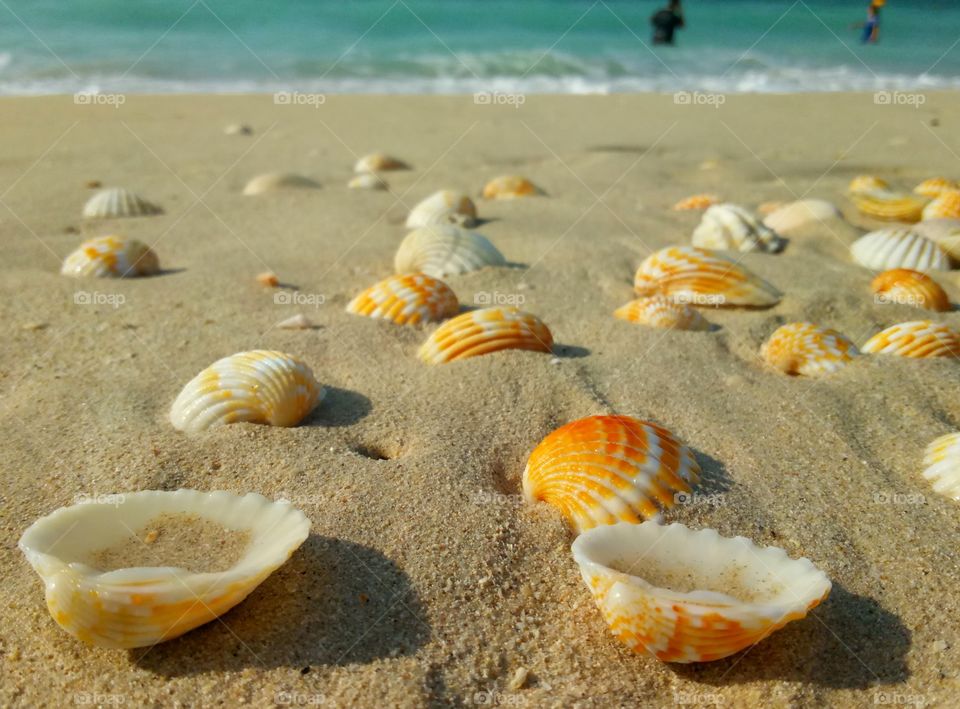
[0,94,960,707]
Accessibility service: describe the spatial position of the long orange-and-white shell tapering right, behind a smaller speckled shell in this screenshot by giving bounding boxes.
[634,246,781,306]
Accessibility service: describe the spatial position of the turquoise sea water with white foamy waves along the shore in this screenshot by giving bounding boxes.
[0,0,960,94]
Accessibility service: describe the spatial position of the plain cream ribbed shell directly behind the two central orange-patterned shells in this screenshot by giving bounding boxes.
[393,225,506,278]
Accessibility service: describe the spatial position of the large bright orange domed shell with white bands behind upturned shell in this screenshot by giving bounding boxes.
[523,416,700,532]
